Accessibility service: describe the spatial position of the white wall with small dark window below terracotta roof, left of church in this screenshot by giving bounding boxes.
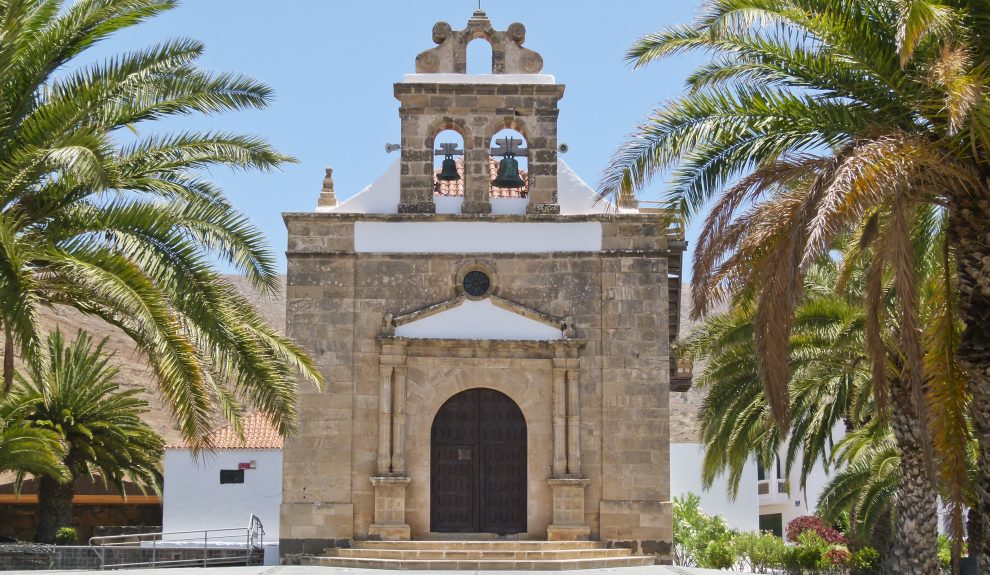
[162,449,282,542]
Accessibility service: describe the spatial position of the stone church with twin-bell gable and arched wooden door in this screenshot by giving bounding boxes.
[280,11,686,561]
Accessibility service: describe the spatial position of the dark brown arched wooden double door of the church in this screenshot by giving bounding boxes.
[430,389,526,535]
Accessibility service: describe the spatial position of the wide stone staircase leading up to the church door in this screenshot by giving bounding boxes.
[302,540,654,571]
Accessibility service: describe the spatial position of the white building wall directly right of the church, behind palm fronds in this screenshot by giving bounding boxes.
[670,443,760,531]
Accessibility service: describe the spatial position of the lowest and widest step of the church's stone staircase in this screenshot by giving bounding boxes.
[301,556,654,571]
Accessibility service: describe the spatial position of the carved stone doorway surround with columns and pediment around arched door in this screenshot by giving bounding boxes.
[369,300,591,541]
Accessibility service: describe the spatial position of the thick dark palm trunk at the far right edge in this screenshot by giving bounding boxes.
[948,188,990,573]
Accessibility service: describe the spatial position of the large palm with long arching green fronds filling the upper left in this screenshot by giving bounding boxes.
[0,0,322,442]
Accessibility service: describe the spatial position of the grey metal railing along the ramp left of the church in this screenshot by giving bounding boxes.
[89,514,265,569]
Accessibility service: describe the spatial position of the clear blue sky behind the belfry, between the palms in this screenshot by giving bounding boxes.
[86,0,698,269]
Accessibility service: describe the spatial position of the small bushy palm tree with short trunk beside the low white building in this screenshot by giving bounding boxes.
[7,329,165,543]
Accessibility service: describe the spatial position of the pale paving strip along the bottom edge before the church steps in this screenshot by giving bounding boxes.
[4,565,751,575]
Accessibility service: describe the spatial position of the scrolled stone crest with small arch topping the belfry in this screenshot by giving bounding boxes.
[416,10,543,74]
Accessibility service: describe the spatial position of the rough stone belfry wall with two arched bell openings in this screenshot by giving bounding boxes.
[395,83,564,214]
